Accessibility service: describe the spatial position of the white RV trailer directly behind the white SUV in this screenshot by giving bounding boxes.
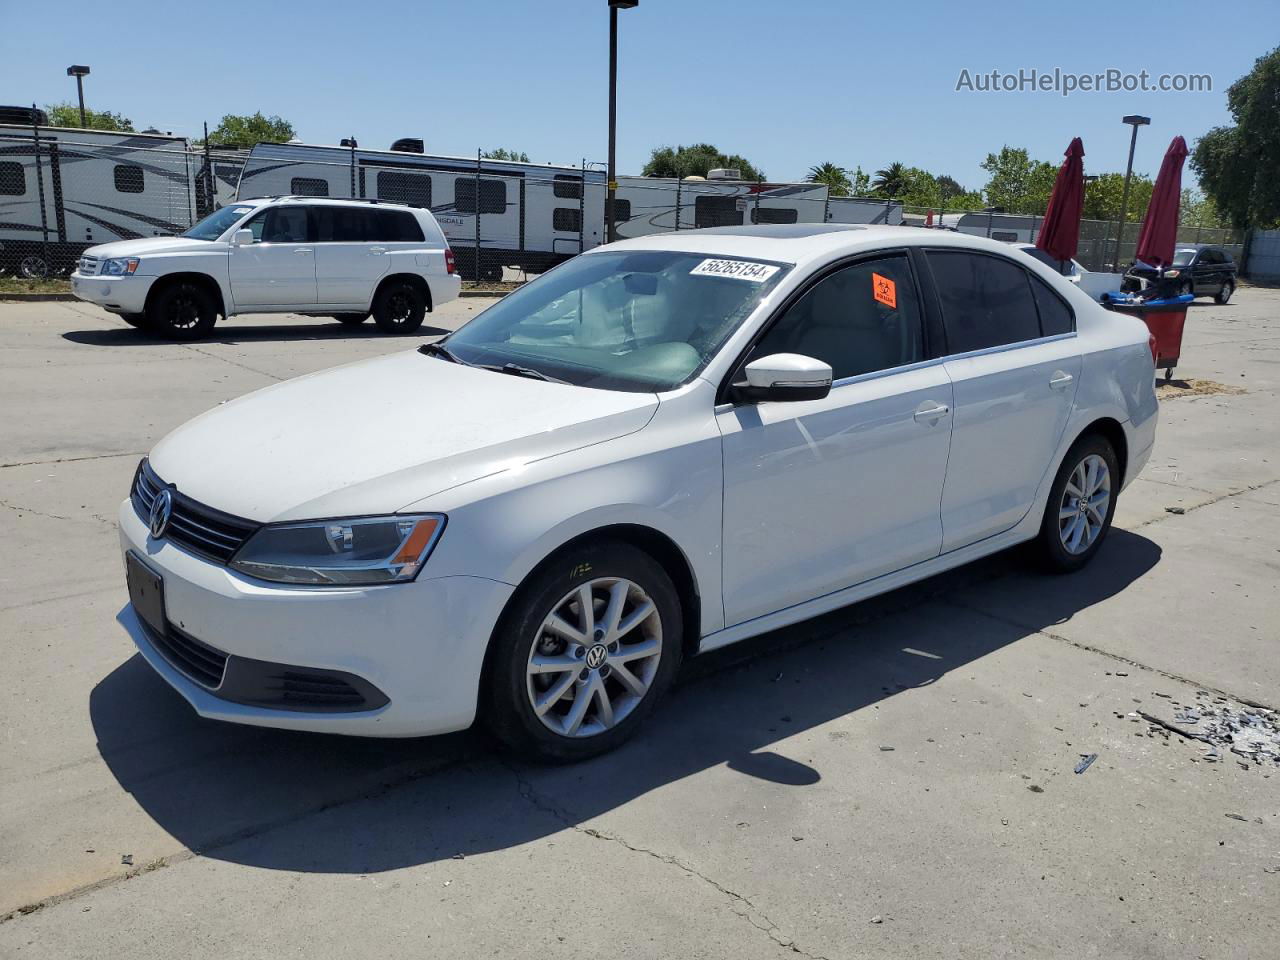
[237,143,605,279]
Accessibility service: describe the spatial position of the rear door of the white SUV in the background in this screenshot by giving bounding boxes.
[311,204,389,310]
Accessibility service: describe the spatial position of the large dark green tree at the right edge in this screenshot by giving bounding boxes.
[1192,47,1280,228]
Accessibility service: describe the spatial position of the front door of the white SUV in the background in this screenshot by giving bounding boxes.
[229,204,316,312]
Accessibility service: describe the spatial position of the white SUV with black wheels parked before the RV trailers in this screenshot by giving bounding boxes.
[72,197,462,339]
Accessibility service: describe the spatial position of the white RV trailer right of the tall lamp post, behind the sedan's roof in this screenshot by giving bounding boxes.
[614,170,827,239]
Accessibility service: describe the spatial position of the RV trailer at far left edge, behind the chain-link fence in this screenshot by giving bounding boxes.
[0,124,197,276]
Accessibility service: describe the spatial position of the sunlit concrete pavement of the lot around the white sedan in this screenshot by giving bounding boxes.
[0,289,1280,957]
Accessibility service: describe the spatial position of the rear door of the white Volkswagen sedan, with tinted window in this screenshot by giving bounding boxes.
[927,250,1082,553]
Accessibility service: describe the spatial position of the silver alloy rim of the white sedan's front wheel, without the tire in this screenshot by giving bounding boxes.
[526,577,662,737]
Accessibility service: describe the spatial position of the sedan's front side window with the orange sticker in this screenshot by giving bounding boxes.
[751,256,924,380]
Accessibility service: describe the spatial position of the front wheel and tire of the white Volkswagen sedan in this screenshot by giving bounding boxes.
[485,540,684,763]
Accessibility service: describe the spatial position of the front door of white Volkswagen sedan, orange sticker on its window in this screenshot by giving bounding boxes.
[717,255,951,626]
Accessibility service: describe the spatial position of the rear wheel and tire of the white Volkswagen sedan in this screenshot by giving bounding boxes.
[1037,434,1120,573]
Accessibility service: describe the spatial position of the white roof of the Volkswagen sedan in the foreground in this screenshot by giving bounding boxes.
[584,224,1034,265]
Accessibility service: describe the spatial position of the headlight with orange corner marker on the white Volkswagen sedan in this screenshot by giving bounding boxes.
[230,513,444,586]
